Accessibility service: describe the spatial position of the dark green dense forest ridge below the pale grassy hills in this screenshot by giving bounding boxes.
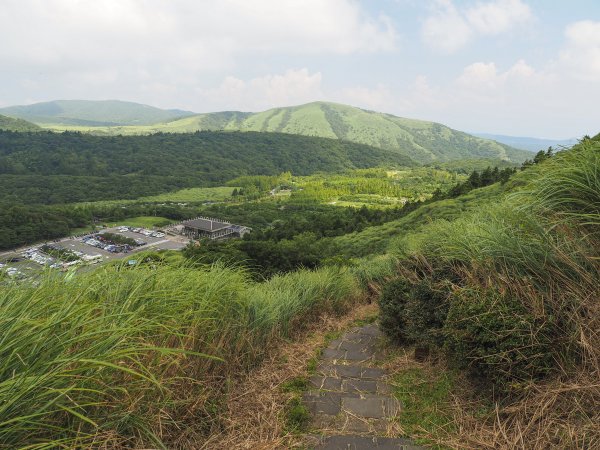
[0,131,415,204]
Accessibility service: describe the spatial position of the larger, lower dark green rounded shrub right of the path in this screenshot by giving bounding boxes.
[444,289,556,391]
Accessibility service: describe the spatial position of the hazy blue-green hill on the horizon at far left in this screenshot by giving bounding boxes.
[0,100,193,127]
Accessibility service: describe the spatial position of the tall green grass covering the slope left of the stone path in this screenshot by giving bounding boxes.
[0,266,359,448]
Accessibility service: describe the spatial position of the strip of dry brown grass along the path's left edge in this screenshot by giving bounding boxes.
[197,304,377,450]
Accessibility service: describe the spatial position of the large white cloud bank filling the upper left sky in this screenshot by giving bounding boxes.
[0,0,397,108]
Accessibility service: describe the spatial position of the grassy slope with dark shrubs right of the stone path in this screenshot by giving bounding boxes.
[382,137,600,449]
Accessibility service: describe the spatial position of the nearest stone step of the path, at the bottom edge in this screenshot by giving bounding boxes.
[311,435,425,450]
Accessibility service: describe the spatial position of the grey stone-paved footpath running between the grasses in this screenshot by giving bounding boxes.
[303,324,423,450]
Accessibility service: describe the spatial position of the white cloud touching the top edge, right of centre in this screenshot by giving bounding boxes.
[421,0,533,53]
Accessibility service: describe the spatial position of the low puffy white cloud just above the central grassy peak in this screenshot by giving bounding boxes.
[197,68,323,111]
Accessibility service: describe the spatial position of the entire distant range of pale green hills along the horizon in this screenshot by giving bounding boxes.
[0,100,531,164]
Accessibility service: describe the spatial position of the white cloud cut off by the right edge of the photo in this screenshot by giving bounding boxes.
[559,20,600,82]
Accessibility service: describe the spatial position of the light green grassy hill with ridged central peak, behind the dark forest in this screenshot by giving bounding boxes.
[149,102,531,163]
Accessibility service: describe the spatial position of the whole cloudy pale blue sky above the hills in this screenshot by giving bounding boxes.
[0,0,600,139]
